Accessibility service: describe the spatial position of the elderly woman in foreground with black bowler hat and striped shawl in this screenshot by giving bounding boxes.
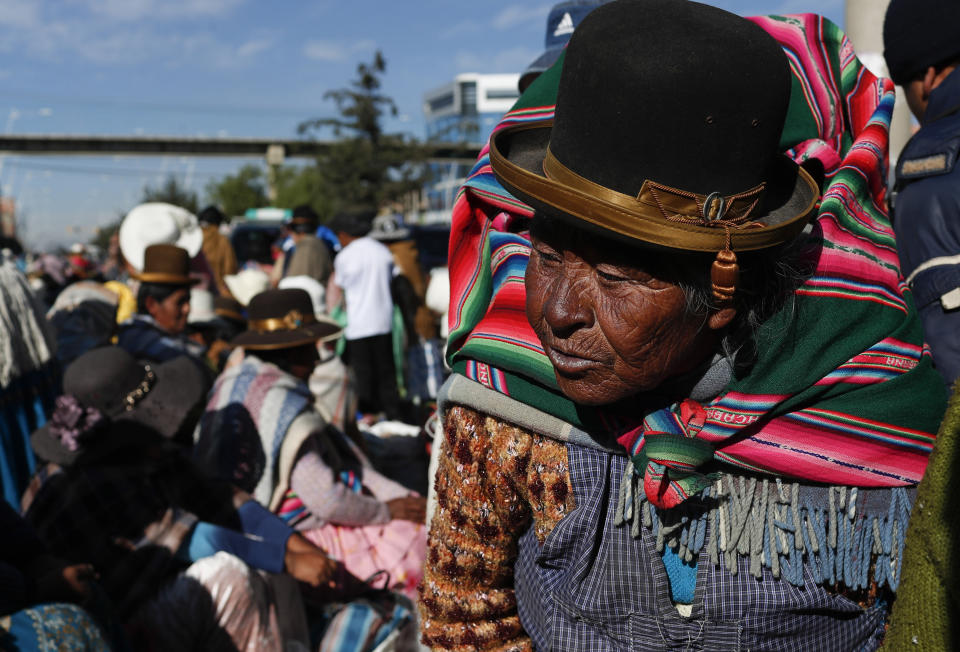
[421,0,945,650]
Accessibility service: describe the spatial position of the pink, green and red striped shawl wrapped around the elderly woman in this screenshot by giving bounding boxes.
[448,14,946,507]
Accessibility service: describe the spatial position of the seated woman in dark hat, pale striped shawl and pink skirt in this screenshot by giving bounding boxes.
[194,289,426,595]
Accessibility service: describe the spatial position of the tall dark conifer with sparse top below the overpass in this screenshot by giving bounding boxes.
[294,51,426,216]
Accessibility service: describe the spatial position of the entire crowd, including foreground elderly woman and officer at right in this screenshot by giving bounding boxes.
[0,0,960,651]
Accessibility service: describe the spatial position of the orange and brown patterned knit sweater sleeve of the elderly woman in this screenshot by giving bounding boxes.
[420,407,574,650]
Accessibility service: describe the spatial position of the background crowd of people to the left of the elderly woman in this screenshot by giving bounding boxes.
[0,202,436,651]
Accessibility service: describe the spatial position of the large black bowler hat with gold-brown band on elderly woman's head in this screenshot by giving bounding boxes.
[490,0,819,258]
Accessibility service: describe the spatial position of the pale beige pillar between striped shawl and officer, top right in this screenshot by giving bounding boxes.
[846,0,913,182]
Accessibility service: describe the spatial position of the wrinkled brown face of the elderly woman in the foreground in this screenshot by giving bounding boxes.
[526,217,717,405]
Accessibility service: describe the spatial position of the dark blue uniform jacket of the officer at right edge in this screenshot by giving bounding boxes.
[893,69,960,385]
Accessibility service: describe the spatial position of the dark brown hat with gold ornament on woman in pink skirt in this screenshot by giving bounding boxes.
[230,288,343,350]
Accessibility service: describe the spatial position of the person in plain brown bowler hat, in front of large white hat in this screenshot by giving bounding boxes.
[117,244,205,362]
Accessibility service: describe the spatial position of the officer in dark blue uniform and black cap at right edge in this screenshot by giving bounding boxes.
[883,0,960,386]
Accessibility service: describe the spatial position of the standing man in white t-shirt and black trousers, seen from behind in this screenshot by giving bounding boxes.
[330,211,401,419]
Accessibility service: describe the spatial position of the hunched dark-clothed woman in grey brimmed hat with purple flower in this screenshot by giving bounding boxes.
[23,347,358,650]
